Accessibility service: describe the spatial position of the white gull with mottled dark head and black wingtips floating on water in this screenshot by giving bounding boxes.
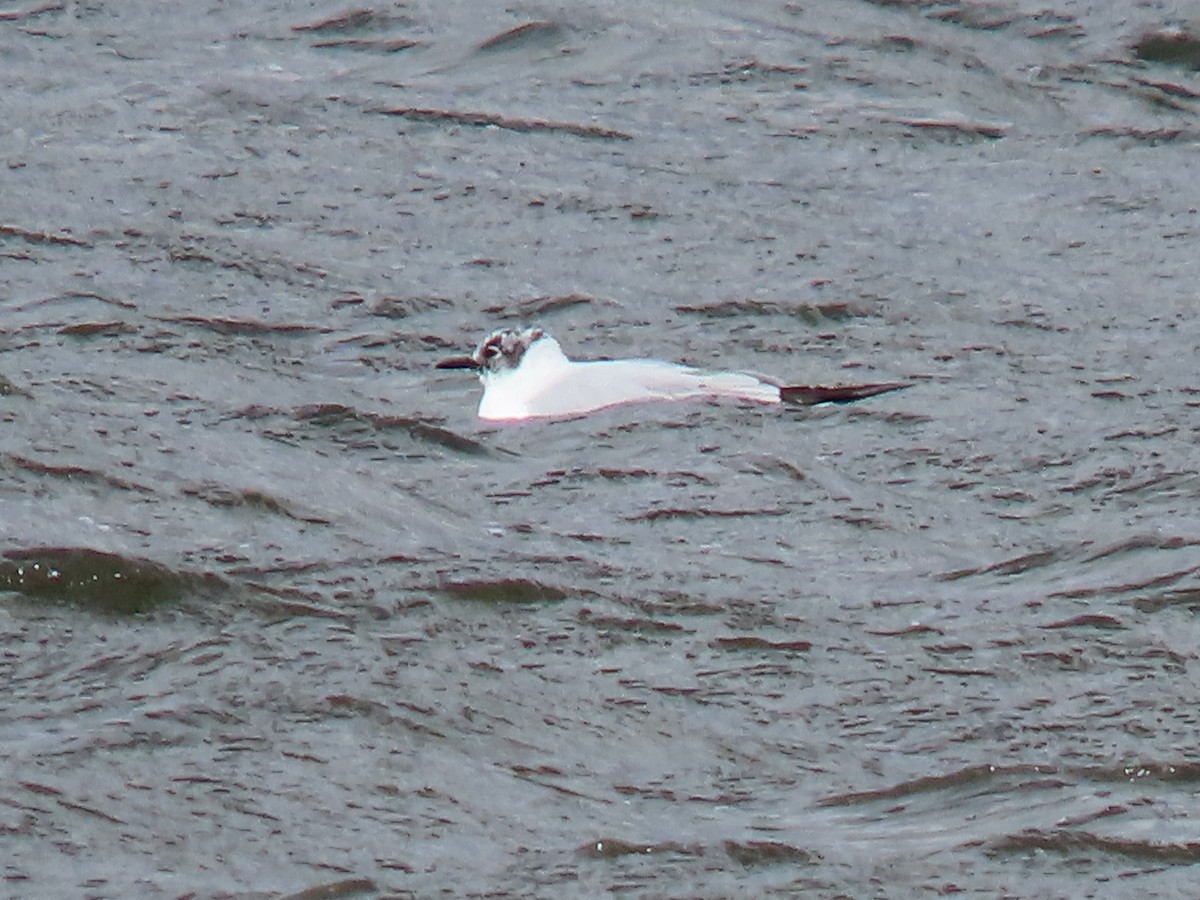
[437,328,910,421]
